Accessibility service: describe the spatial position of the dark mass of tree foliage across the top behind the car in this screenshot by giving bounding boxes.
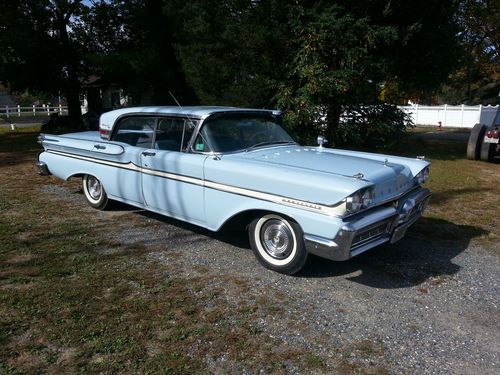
[0,0,492,145]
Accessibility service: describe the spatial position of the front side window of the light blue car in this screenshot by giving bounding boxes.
[155,118,194,151]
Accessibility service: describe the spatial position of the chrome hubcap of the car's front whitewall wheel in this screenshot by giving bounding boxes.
[261,219,294,259]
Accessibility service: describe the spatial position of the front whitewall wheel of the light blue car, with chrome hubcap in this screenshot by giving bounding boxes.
[248,214,307,275]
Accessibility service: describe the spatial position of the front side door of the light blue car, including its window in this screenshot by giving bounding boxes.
[141,117,206,224]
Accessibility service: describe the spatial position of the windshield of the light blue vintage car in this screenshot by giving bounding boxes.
[194,113,295,153]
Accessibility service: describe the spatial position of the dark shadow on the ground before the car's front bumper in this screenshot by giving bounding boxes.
[298,218,488,289]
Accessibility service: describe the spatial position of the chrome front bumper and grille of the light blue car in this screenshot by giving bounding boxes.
[304,188,431,260]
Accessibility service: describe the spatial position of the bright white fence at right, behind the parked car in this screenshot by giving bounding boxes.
[399,104,500,128]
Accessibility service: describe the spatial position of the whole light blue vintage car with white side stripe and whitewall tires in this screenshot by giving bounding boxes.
[37,107,431,274]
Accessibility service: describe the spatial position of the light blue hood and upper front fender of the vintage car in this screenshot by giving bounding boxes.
[205,146,429,206]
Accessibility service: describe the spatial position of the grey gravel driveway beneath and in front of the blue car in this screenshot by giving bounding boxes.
[44,186,500,374]
